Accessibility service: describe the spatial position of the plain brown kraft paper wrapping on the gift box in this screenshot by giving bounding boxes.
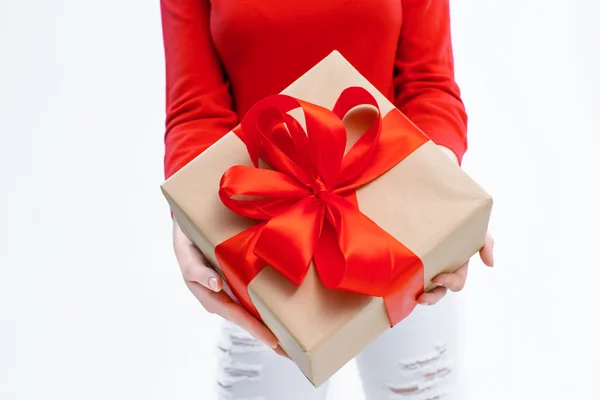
[162,52,492,386]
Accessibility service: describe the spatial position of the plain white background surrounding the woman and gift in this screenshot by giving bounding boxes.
[0,0,600,400]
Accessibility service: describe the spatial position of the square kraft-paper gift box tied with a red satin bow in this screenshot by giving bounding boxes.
[162,52,492,386]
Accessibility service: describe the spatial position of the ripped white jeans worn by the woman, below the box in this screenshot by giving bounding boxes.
[217,294,459,400]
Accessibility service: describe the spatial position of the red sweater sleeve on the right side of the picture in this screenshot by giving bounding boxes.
[394,0,467,160]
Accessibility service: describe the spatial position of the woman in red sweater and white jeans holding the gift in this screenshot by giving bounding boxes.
[161,0,493,400]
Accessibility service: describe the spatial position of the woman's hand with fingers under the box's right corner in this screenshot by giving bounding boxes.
[417,233,494,305]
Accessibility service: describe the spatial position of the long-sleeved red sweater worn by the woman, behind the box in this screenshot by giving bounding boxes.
[161,0,467,177]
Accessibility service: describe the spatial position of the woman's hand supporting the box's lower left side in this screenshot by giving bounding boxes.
[173,223,285,356]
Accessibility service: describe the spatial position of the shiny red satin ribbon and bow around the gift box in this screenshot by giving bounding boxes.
[215,87,428,325]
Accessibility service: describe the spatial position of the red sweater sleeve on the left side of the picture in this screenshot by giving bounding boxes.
[161,0,237,178]
